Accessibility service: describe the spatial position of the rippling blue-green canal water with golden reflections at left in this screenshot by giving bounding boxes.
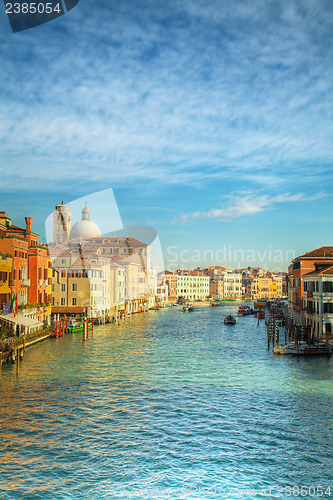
[0,304,333,500]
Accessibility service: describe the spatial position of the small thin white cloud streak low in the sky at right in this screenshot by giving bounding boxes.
[172,192,326,225]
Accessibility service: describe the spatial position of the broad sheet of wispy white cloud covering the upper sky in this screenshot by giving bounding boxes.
[0,0,333,191]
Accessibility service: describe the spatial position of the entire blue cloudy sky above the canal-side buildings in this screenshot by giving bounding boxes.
[0,0,333,271]
